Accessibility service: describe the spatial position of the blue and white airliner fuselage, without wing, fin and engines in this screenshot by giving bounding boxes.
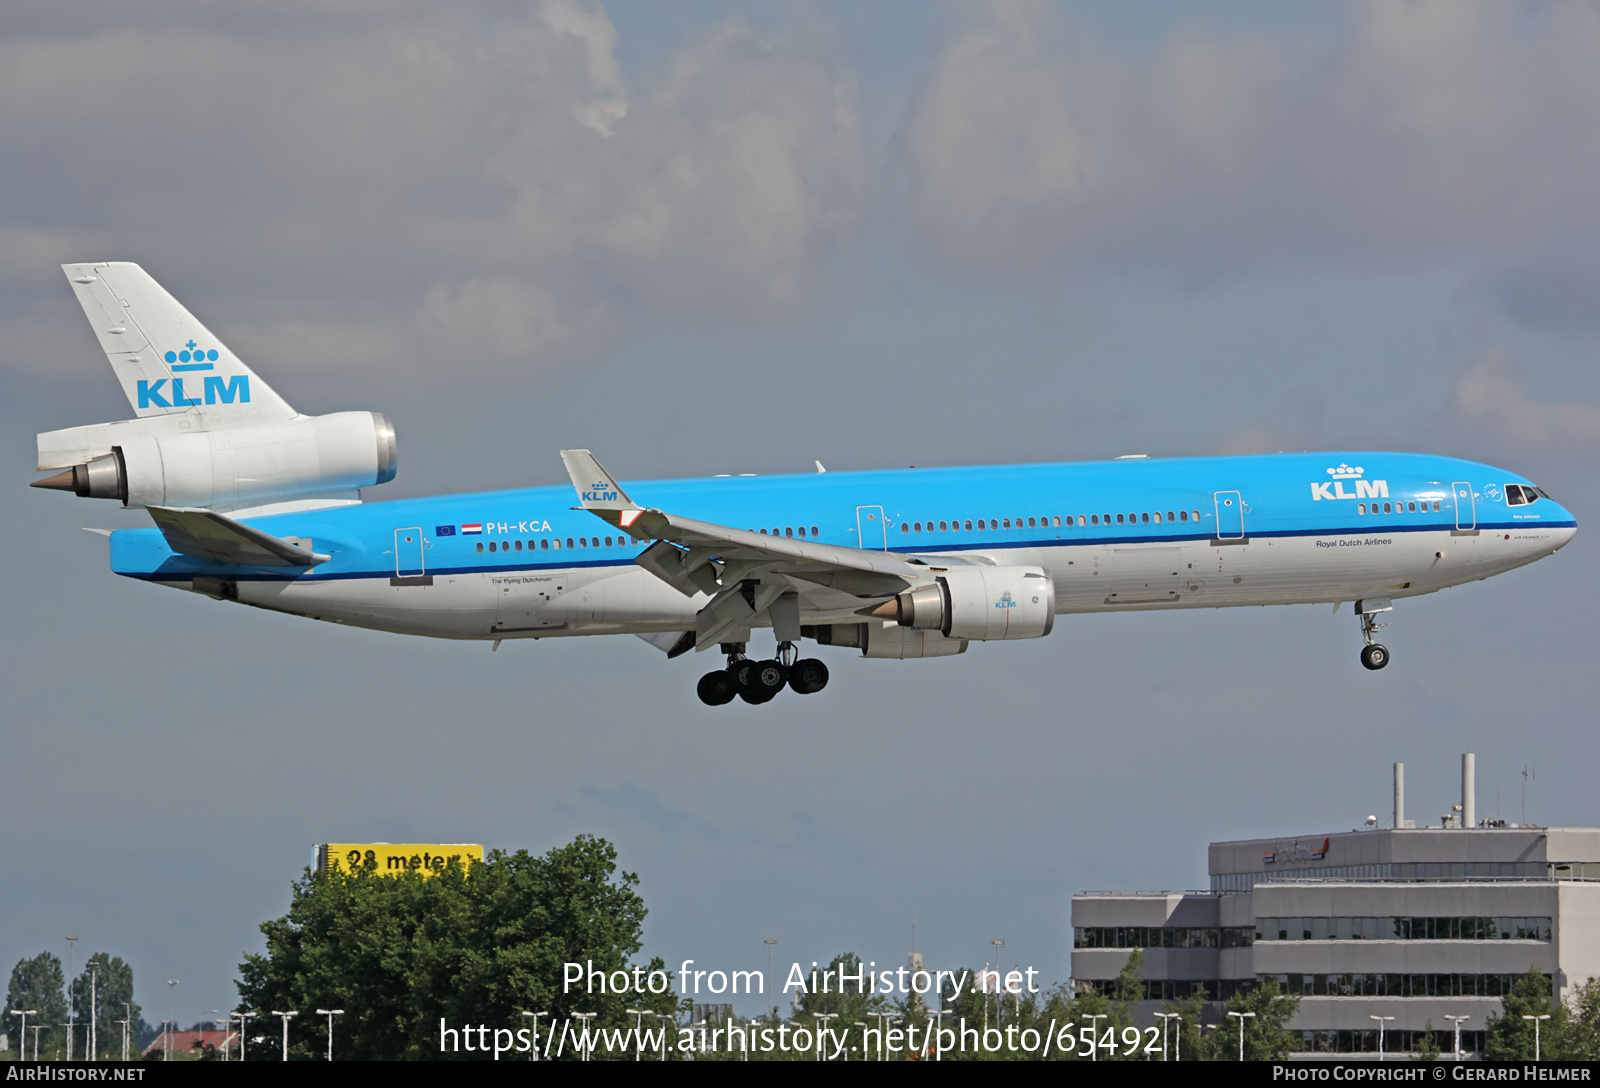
[103,451,1576,640]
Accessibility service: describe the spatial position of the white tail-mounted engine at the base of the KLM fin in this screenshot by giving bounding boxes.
[34,411,395,507]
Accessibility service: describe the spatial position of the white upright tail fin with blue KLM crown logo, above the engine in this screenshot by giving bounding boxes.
[61,261,296,422]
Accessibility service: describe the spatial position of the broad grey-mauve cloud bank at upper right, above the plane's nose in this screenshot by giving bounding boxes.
[901,2,1600,305]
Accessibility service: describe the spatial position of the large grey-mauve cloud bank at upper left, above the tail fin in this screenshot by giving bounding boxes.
[0,0,862,376]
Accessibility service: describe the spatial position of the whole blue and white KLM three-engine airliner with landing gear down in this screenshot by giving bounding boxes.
[34,264,1578,706]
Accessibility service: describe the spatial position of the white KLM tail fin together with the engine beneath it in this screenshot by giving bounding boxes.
[34,264,395,515]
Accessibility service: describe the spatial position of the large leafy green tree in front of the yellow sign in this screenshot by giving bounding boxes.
[238,835,677,1059]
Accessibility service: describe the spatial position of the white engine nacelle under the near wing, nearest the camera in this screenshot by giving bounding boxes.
[874,566,1056,642]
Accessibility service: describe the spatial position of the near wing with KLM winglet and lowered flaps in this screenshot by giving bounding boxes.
[562,450,930,650]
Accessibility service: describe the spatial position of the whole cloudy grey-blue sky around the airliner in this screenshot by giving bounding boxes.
[0,0,1600,1021]
